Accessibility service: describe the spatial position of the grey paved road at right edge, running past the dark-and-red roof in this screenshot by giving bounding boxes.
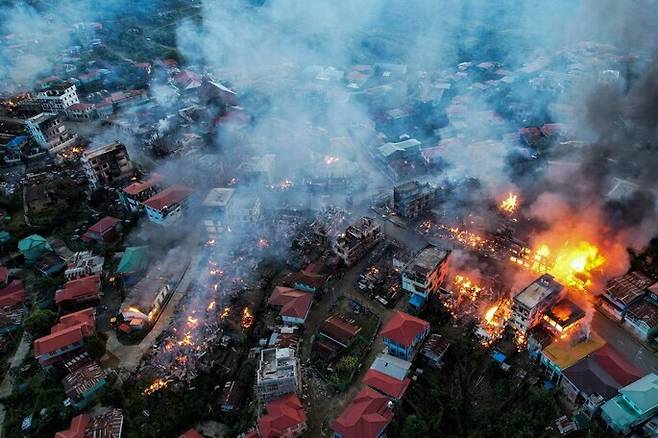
[592,311,658,373]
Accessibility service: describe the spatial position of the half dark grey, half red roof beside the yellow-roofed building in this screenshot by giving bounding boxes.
[563,345,643,400]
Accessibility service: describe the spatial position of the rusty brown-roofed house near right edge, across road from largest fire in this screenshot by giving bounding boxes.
[600,271,654,321]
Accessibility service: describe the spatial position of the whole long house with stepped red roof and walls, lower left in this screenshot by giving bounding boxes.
[34,307,95,367]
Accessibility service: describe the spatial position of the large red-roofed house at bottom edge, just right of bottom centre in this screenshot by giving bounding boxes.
[331,386,394,438]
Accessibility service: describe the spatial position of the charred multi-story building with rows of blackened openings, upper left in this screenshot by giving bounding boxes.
[80,142,133,189]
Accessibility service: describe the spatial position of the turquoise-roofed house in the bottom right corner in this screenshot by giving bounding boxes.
[601,373,658,434]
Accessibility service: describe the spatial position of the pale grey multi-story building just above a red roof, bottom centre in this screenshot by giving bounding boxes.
[256,348,300,402]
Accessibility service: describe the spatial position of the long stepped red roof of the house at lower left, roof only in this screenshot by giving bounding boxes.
[34,307,94,356]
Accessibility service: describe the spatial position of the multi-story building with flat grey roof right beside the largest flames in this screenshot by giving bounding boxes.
[509,274,564,333]
